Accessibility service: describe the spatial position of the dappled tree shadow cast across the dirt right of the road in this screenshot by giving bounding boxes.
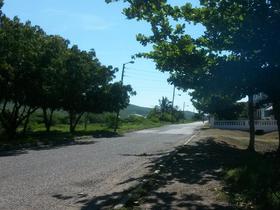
[79,139,247,210]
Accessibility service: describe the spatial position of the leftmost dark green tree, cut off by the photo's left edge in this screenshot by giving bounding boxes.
[0,16,45,139]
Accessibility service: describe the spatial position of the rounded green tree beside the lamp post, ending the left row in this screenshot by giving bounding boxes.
[62,46,134,132]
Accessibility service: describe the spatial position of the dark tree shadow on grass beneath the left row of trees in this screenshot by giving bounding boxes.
[0,130,121,157]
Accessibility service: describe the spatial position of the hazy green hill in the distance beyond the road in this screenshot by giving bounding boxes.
[120,104,194,119]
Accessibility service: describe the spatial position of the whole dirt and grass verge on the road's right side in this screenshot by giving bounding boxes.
[105,129,280,210]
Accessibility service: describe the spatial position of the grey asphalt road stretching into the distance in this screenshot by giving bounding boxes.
[0,123,202,210]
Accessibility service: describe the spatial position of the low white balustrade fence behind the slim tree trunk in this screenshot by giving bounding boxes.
[210,120,277,132]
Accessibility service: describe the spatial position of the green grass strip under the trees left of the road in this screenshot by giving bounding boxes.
[0,119,191,151]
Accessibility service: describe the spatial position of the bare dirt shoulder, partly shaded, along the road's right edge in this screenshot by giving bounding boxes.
[111,129,278,209]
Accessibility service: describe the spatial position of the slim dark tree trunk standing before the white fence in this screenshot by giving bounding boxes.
[248,94,255,152]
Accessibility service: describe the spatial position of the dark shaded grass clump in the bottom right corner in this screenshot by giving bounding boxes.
[224,153,280,210]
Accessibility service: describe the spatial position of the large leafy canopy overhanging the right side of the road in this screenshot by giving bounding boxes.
[107,0,280,151]
